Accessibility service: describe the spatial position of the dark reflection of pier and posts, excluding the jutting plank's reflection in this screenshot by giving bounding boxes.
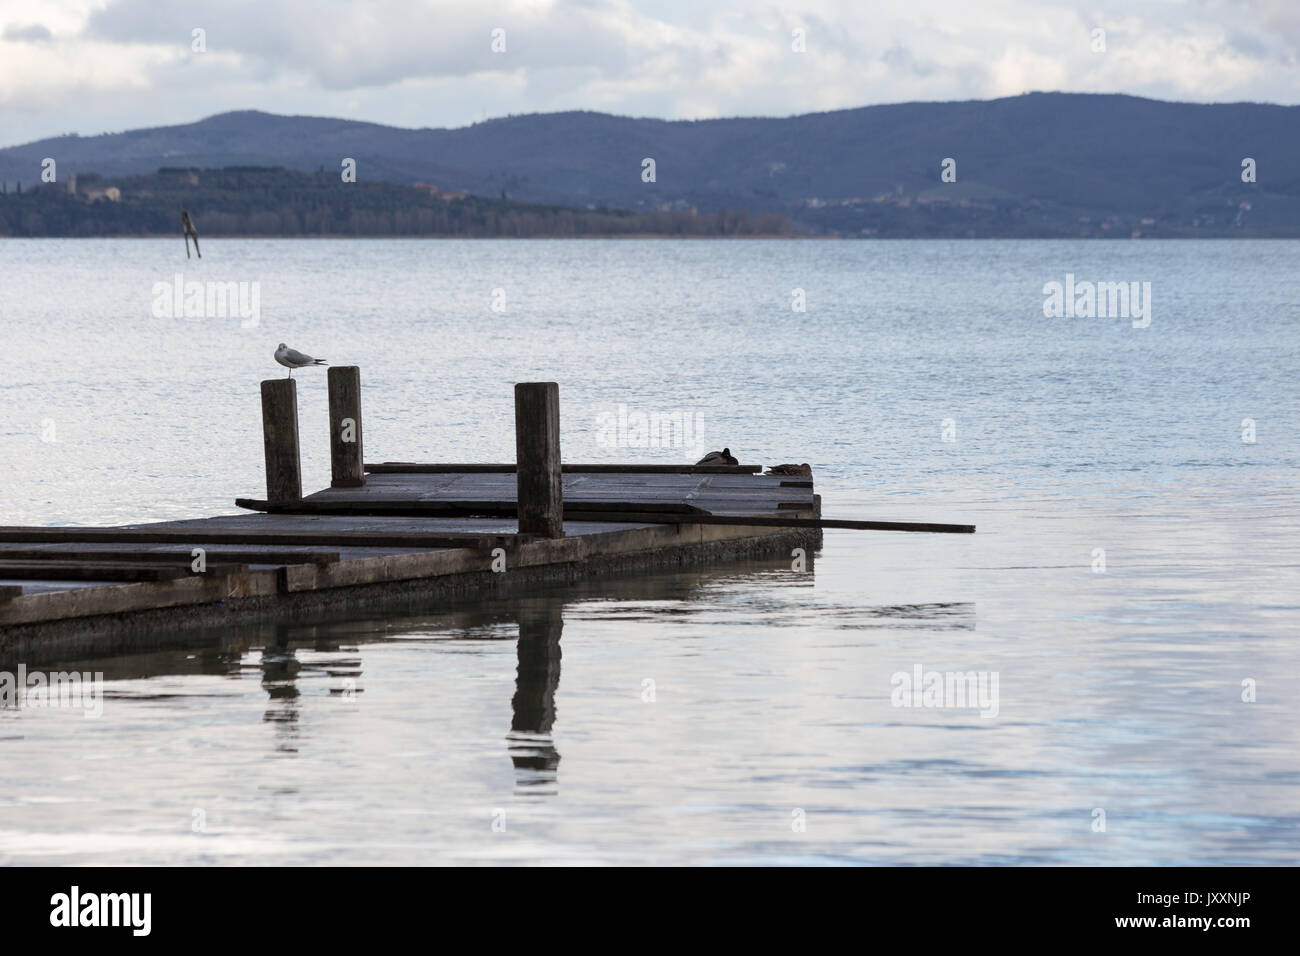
[12,561,813,796]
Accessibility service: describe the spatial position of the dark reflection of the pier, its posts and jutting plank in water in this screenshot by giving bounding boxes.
[12,554,975,816]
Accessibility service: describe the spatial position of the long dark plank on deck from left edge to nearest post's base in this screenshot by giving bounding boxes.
[0,528,517,549]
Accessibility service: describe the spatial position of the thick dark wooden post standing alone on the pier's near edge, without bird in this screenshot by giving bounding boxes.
[515,381,564,537]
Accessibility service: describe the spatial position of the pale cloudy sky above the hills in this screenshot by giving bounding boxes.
[0,0,1300,146]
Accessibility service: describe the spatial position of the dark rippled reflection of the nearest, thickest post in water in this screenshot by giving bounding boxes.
[508,598,564,786]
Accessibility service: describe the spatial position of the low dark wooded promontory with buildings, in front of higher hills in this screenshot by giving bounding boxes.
[0,166,790,238]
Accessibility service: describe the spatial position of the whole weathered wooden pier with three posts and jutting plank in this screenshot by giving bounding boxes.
[0,367,974,661]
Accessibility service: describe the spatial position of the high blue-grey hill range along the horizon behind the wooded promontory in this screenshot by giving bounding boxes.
[0,94,1300,235]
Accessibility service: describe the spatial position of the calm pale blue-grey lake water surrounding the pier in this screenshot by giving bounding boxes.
[0,239,1300,865]
